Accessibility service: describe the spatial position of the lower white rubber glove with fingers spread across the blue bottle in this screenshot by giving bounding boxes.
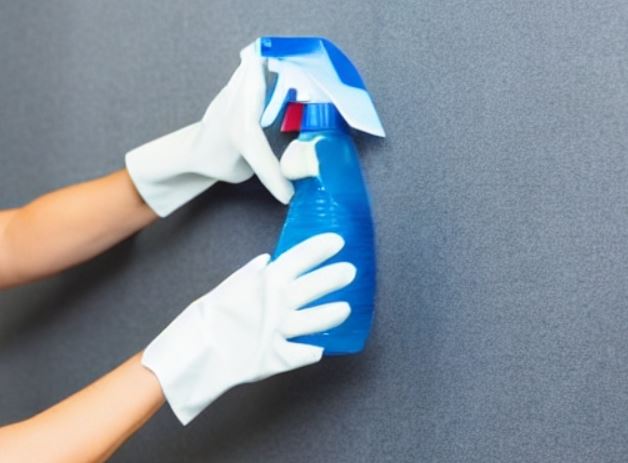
[142,233,356,424]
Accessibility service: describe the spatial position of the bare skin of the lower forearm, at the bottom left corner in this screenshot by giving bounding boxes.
[0,354,164,463]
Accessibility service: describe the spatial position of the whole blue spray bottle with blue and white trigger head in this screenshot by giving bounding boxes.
[259,37,384,355]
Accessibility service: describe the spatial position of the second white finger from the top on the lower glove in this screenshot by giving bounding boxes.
[286,262,356,309]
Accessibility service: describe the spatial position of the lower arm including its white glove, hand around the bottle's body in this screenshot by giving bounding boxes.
[0,233,356,463]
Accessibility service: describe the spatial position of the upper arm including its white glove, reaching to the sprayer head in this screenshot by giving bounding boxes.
[0,44,293,289]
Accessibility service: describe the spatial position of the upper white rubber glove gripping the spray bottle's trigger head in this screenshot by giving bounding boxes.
[126,42,294,217]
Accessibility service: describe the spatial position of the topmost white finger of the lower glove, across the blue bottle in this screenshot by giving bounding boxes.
[270,233,345,279]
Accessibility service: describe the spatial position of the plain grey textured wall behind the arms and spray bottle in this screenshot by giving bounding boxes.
[0,0,628,462]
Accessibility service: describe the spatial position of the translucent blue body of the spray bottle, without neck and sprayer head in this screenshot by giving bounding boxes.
[273,128,376,355]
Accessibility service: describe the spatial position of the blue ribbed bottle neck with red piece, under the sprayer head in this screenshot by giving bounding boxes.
[283,103,349,133]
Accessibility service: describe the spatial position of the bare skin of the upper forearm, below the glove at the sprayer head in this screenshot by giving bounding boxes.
[0,170,157,288]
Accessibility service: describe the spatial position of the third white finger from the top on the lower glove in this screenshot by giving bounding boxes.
[281,302,351,338]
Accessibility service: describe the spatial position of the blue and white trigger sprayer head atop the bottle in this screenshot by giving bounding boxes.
[257,37,385,137]
